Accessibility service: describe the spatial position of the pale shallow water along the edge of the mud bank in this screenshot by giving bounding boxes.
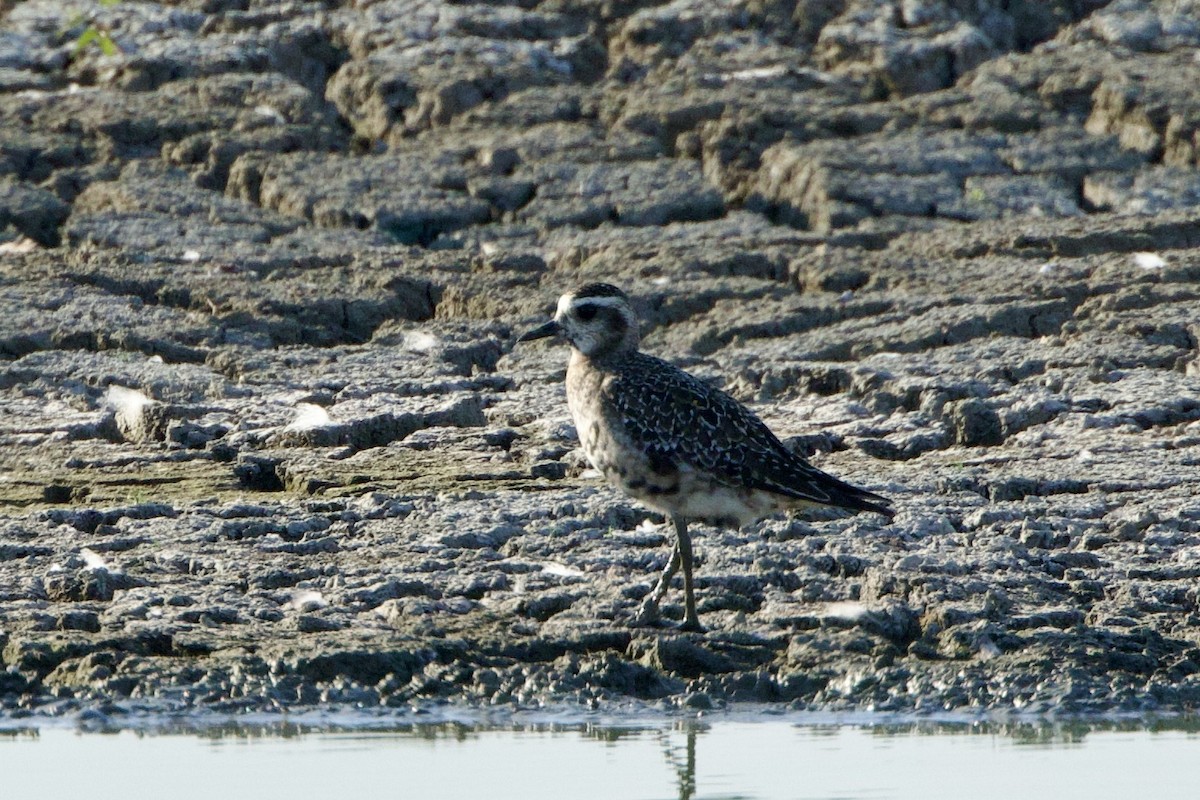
[0,718,1200,800]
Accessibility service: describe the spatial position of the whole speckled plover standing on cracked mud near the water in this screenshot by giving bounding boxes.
[517,283,895,631]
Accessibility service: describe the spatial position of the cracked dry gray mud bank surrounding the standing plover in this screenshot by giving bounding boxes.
[0,0,1200,718]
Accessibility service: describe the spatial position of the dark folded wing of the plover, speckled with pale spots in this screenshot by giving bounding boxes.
[605,353,893,517]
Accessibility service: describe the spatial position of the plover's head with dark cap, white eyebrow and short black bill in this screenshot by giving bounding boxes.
[517,283,640,359]
